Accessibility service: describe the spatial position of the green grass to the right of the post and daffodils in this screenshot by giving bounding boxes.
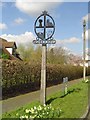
[49,79,88,118]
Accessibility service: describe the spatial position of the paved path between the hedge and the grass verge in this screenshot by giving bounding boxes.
[0,79,81,113]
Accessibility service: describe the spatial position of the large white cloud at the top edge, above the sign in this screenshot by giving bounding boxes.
[15,0,61,15]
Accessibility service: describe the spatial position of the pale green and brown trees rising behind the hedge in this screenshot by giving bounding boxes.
[18,44,82,64]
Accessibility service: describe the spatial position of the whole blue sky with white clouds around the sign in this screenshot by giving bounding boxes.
[0,0,90,55]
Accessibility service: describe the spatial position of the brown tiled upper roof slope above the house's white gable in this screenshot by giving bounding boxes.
[0,38,17,49]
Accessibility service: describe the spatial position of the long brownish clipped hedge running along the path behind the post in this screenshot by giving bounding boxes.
[2,60,90,96]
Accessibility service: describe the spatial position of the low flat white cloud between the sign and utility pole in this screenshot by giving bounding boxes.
[57,37,80,44]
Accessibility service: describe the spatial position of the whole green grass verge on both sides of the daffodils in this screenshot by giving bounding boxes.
[3,81,88,118]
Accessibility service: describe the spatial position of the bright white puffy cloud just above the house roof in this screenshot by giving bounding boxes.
[0,32,35,46]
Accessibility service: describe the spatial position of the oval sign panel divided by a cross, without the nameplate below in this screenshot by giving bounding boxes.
[34,11,55,40]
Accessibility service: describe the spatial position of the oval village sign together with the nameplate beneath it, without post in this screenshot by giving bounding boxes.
[33,11,56,44]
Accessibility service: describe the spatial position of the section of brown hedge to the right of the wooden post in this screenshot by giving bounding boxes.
[47,65,83,85]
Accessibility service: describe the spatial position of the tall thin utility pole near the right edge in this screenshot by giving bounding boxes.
[83,20,86,81]
